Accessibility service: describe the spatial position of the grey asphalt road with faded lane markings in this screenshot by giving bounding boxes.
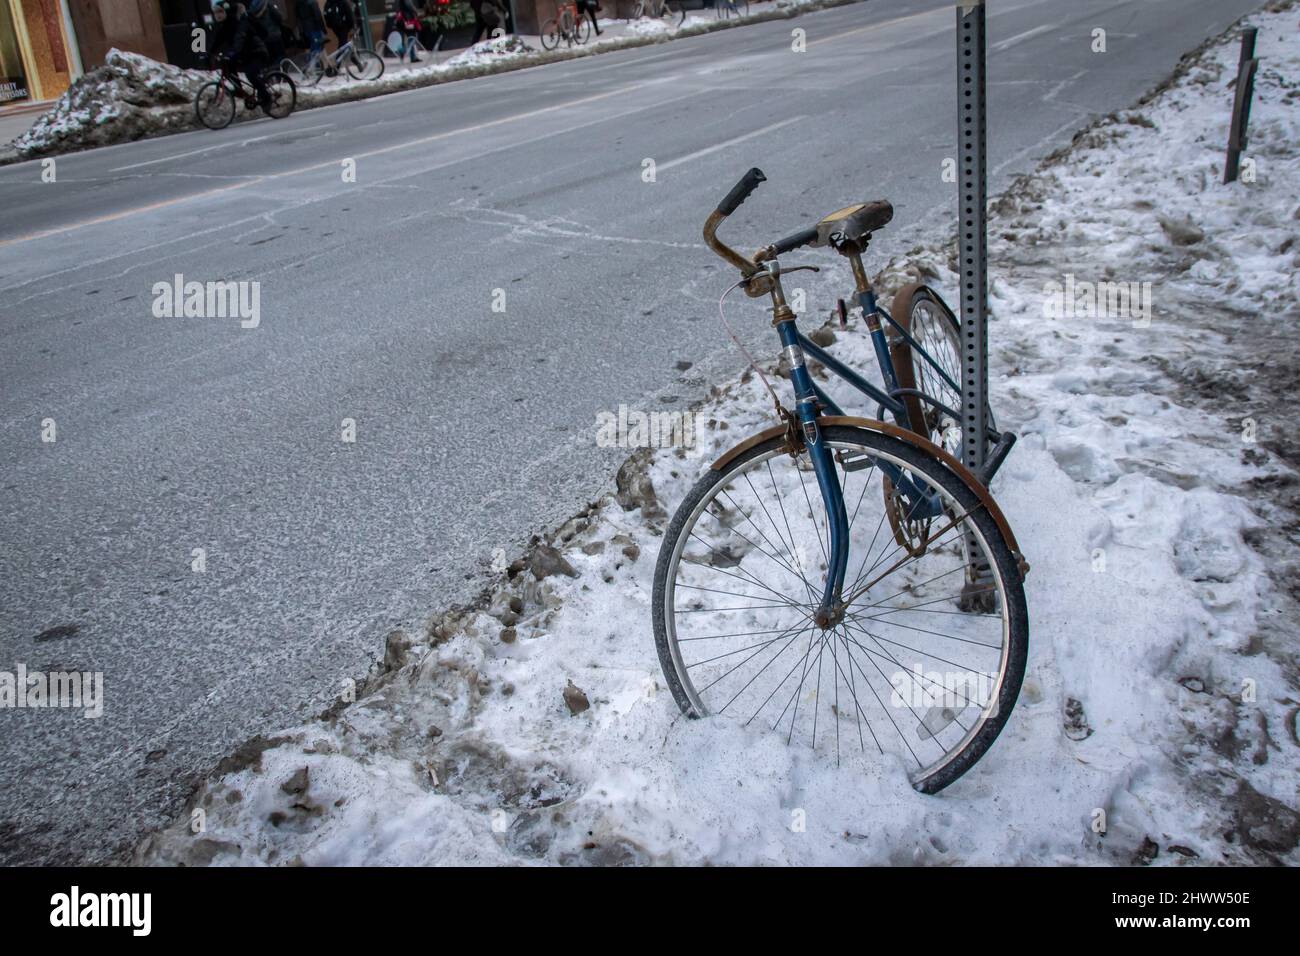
[0,0,1260,862]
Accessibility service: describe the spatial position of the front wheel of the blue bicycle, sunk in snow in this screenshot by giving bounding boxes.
[653,425,1028,793]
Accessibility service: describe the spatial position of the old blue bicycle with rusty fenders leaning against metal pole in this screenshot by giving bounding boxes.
[653,169,1028,793]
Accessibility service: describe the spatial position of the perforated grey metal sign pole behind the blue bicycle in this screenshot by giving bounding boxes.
[957,0,988,473]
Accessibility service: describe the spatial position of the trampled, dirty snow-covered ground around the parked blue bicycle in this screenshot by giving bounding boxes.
[139,4,1300,865]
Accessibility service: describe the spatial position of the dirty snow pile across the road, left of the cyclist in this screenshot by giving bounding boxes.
[14,49,211,156]
